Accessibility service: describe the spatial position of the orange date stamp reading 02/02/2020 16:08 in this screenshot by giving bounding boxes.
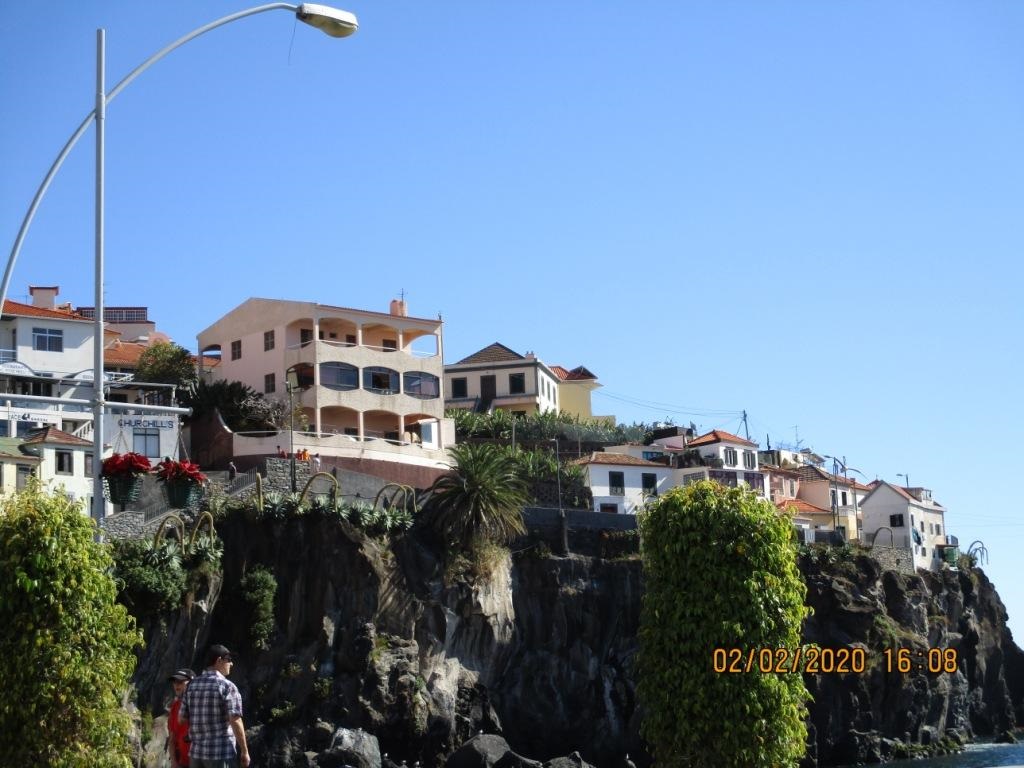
[711,645,959,675]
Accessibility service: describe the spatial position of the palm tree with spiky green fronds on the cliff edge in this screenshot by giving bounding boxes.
[430,443,526,549]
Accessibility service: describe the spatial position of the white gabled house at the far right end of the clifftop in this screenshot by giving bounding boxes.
[860,480,949,570]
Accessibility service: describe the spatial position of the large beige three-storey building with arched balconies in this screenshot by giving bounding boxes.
[199,298,455,473]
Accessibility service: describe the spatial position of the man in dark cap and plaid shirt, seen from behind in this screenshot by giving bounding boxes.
[179,645,249,768]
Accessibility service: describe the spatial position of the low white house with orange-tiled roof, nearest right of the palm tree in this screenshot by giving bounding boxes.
[572,452,672,515]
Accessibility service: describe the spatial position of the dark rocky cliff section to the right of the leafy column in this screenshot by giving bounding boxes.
[801,555,1024,765]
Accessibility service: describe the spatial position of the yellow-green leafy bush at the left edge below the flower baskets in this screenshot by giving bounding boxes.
[0,483,142,768]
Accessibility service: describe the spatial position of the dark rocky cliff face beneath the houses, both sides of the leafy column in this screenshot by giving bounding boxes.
[136,516,1024,768]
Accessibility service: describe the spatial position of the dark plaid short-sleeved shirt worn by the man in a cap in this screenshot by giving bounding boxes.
[181,670,242,760]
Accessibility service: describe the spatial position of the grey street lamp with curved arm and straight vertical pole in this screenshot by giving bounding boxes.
[0,3,358,525]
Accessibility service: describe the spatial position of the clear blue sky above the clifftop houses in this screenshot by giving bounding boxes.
[0,0,1024,641]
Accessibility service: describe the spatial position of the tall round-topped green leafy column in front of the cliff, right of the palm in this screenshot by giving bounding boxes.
[637,481,808,768]
